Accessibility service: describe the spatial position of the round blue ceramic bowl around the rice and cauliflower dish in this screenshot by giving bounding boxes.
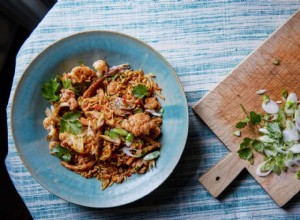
[11,31,188,208]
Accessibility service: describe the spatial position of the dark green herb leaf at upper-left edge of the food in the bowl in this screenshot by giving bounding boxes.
[42,79,61,102]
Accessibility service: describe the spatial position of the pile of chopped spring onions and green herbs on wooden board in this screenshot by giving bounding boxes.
[235,90,300,179]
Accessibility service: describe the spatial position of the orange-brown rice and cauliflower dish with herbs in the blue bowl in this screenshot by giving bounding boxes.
[42,60,164,189]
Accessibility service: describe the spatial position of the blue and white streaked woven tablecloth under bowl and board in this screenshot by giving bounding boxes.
[6,0,300,219]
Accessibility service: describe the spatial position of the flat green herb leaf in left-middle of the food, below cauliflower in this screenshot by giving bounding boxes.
[59,111,82,135]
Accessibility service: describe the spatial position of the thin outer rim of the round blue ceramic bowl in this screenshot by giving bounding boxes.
[9,30,189,208]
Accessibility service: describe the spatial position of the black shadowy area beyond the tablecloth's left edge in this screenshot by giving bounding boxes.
[0,0,56,220]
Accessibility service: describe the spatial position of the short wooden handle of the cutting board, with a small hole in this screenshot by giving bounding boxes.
[199,152,249,197]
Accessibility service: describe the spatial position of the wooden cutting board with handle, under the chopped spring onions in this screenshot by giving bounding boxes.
[193,10,300,206]
